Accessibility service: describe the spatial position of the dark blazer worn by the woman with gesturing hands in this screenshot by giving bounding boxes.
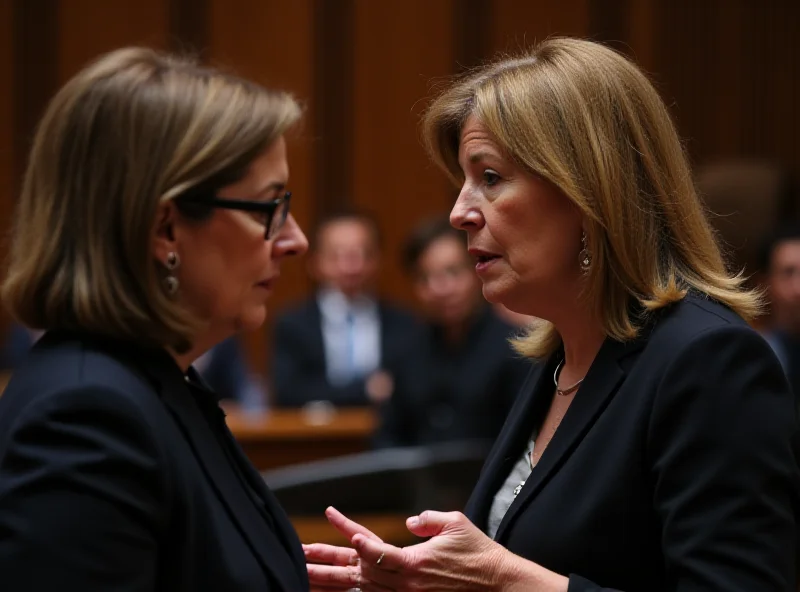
[466,296,800,592]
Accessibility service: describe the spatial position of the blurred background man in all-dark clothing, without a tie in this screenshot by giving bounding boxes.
[376,219,531,447]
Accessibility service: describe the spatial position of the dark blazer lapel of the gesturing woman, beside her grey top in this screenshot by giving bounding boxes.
[495,339,629,541]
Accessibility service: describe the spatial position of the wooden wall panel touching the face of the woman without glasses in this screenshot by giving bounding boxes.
[350,0,457,304]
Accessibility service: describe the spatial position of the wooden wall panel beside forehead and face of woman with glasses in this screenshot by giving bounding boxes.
[208,0,318,374]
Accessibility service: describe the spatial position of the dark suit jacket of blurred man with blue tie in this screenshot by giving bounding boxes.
[272,296,417,407]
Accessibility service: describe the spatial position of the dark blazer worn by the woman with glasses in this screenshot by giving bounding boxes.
[0,333,308,592]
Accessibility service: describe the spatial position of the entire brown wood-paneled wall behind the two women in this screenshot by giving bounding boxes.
[0,0,800,382]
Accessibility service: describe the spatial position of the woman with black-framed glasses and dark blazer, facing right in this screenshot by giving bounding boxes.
[0,48,308,592]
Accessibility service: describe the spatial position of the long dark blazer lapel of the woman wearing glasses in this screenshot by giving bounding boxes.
[157,366,302,590]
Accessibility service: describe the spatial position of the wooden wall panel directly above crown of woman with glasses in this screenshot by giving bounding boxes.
[57,0,169,83]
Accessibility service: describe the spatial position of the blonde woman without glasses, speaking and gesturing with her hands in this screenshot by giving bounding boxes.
[306,39,800,592]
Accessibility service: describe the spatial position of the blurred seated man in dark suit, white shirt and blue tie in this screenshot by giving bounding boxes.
[272,211,416,407]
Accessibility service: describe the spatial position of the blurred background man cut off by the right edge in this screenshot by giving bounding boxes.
[761,224,800,404]
